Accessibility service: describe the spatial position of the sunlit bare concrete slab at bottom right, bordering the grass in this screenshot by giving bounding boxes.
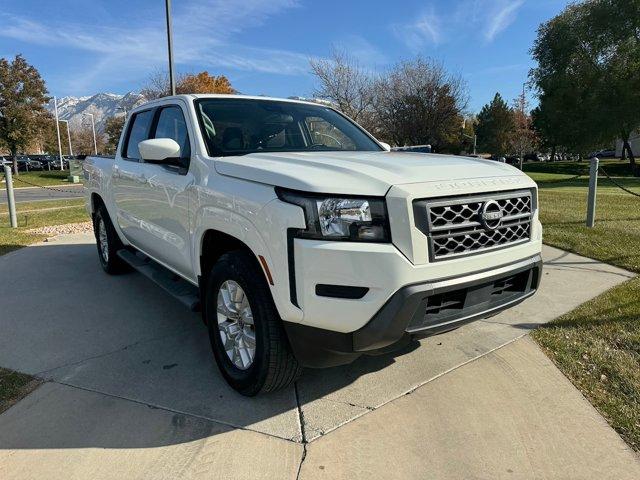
[300,337,640,480]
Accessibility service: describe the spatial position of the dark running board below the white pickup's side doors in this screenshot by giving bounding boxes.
[117,248,200,312]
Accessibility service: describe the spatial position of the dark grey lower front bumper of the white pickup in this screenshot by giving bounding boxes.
[284,254,542,368]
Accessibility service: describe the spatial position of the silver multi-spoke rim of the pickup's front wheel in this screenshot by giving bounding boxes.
[217,280,256,370]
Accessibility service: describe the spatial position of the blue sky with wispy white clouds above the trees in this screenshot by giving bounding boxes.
[0,0,568,112]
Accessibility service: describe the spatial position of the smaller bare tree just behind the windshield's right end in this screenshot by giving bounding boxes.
[309,48,375,127]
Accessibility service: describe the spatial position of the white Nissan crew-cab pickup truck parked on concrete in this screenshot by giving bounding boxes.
[84,95,542,395]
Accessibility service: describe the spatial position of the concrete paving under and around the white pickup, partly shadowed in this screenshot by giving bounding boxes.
[0,235,640,479]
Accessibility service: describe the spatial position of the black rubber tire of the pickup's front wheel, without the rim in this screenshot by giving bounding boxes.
[205,252,272,396]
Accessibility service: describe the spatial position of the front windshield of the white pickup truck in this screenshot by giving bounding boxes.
[196,98,382,156]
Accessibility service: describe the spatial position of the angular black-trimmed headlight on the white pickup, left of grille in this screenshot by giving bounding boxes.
[276,188,391,242]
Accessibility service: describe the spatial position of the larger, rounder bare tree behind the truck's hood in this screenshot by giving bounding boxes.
[374,57,468,151]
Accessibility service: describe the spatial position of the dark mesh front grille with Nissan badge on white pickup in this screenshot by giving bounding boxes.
[414,190,534,261]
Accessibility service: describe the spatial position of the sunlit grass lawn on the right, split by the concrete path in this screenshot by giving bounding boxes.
[527,162,640,451]
